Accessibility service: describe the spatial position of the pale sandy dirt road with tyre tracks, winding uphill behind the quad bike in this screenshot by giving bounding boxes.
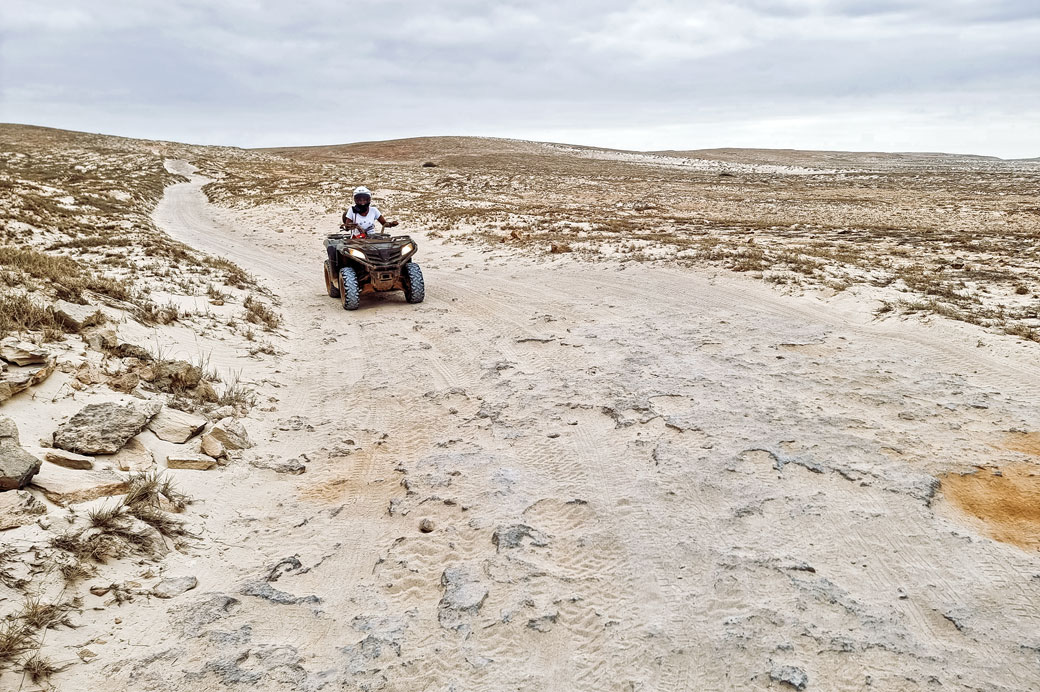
[89,163,1040,692]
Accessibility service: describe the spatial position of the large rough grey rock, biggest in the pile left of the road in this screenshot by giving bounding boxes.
[54,402,161,454]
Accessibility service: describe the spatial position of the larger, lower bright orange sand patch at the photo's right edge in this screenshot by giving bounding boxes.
[939,463,1040,550]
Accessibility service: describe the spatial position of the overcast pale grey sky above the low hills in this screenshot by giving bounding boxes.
[0,0,1040,157]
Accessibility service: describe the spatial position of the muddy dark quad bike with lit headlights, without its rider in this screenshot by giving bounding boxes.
[324,227,425,310]
